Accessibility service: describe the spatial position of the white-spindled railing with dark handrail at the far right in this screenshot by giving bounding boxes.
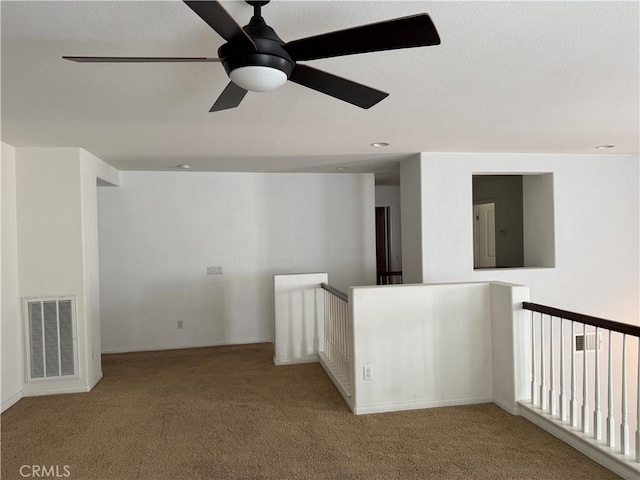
[523,302,640,468]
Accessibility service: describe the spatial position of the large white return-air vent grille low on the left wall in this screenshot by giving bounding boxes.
[25,297,78,380]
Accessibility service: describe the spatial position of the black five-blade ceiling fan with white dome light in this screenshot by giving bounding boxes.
[62,0,440,112]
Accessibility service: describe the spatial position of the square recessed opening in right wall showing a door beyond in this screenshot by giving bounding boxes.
[472,173,555,269]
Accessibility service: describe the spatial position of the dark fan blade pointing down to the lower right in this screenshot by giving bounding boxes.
[289,64,389,108]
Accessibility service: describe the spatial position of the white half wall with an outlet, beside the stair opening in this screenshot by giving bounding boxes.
[349,283,496,414]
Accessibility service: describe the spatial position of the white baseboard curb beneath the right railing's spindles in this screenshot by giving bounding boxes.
[520,402,640,480]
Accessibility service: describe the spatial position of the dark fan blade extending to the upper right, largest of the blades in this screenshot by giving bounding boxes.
[284,13,440,61]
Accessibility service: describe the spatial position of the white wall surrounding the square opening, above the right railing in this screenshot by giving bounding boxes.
[412,154,640,324]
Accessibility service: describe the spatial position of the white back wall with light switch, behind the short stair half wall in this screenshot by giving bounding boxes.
[98,172,375,352]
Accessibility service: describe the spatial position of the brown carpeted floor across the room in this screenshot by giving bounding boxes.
[1,344,618,480]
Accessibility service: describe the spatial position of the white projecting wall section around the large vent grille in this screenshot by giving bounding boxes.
[16,148,118,395]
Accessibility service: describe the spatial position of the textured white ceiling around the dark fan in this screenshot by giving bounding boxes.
[1,0,640,180]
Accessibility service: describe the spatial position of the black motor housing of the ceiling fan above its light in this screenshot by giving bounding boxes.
[218,16,295,78]
